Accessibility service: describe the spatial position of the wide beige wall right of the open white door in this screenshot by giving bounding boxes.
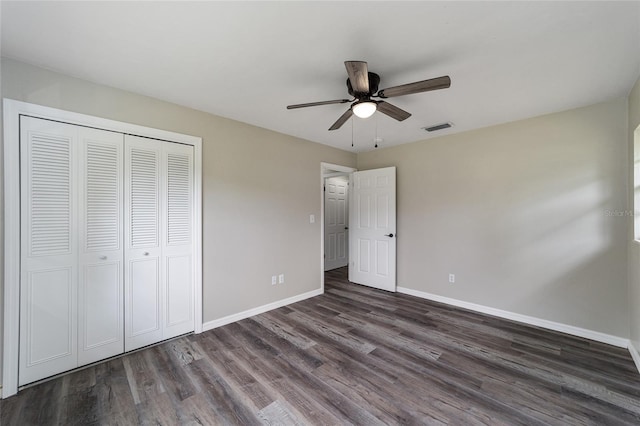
[358,99,629,337]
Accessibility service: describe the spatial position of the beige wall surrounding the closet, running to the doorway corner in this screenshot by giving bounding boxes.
[0,59,355,382]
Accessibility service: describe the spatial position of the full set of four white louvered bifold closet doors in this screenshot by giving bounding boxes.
[18,115,197,385]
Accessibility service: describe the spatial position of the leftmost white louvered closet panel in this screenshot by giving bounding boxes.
[19,116,78,385]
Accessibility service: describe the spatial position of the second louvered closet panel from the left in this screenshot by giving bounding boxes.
[78,127,124,365]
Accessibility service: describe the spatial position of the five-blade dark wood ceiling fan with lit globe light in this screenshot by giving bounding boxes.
[287,61,451,130]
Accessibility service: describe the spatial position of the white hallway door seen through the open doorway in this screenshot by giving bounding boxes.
[324,176,349,271]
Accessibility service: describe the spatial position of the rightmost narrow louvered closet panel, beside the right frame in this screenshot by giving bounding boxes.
[162,143,194,339]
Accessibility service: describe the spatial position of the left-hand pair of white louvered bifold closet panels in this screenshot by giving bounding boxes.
[19,117,124,385]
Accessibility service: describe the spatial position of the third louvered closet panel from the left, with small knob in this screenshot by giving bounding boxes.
[125,135,163,351]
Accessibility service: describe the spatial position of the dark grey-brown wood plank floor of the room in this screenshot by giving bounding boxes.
[0,269,640,426]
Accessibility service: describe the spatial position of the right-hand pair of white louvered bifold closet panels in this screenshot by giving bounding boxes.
[125,135,195,351]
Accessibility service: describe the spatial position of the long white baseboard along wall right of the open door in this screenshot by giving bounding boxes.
[397,287,628,350]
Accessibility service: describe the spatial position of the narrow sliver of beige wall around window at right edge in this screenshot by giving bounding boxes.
[628,78,640,350]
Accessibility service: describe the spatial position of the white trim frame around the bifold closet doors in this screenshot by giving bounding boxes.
[1,98,202,398]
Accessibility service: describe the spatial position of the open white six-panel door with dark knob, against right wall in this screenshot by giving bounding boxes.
[349,167,396,291]
